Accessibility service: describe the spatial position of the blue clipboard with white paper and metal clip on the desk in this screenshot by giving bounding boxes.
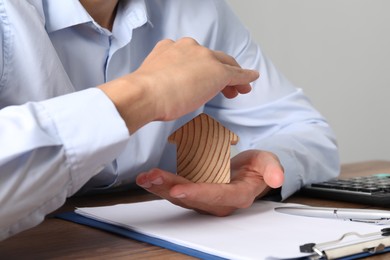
[56,200,390,260]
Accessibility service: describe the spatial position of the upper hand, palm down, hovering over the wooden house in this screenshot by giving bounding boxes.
[100,38,259,133]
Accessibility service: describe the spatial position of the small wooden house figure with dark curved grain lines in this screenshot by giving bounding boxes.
[168,113,238,183]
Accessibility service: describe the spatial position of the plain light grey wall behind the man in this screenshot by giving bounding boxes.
[228,0,390,163]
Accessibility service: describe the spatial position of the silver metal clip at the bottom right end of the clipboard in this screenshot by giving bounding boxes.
[299,228,390,260]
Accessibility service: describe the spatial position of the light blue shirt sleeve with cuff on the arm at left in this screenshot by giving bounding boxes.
[0,88,129,240]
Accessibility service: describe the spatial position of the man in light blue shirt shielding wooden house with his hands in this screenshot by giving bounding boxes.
[0,0,338,239]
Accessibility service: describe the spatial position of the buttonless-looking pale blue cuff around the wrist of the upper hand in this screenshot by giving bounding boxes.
[41,88,129,194]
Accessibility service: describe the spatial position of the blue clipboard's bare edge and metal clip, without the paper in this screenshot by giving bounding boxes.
[56,212,390,260]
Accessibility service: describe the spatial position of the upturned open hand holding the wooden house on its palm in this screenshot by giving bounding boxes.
[136,150,284,216]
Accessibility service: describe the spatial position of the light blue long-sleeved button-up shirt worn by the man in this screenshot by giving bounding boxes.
[0,0,339,239]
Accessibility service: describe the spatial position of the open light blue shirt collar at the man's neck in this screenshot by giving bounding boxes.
[42,0,151,33]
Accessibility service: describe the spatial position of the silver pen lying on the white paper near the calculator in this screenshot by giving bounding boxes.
[275,206,390,225]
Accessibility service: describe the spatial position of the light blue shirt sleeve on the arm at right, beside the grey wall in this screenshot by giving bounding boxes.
[206,0,340,199]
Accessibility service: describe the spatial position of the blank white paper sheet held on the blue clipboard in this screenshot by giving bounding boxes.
[76,200,384,259]
